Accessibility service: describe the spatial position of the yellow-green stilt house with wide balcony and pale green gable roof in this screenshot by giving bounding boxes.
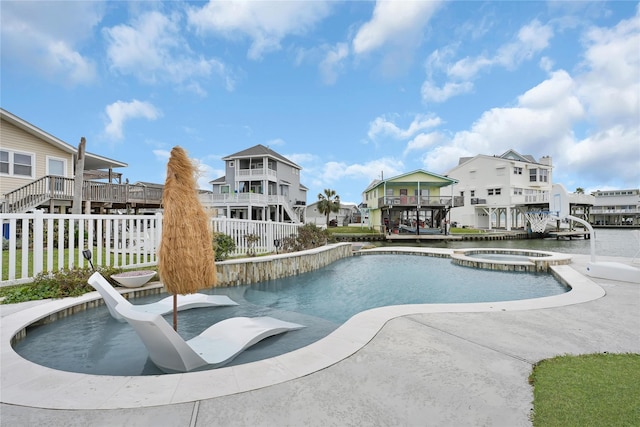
[360,170,461,234]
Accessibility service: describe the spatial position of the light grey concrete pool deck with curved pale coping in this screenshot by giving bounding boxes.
[0,255,640,426]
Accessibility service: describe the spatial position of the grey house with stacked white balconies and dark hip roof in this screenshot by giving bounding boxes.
[206,144,308,223]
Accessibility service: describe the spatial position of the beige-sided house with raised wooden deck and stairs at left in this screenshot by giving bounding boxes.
[0,109,162,213]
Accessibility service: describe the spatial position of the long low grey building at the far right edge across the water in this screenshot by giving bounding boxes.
[589,188,640,227]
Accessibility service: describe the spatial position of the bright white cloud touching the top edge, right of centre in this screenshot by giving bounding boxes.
[353,0,440,55]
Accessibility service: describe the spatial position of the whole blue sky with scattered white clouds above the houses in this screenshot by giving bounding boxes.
[0,0,640,203]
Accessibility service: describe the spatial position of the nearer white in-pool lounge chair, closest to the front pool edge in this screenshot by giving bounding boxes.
[116,304,304,373]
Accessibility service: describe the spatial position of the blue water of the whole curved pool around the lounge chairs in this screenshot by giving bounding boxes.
[14,255,568,375]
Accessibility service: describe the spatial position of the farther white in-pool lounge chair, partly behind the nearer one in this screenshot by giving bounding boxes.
[89,272,238,322]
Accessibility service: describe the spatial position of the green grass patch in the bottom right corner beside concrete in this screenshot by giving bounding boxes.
[530,353,640,427]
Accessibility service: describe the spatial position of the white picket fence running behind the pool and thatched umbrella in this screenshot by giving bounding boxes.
[0,211,300,286]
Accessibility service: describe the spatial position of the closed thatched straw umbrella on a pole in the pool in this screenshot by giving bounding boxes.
[158,147,217,330]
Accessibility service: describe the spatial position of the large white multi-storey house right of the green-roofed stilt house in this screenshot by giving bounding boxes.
[446,150,553,230]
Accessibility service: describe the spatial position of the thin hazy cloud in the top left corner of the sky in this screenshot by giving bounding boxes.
[0,1,99,85]
